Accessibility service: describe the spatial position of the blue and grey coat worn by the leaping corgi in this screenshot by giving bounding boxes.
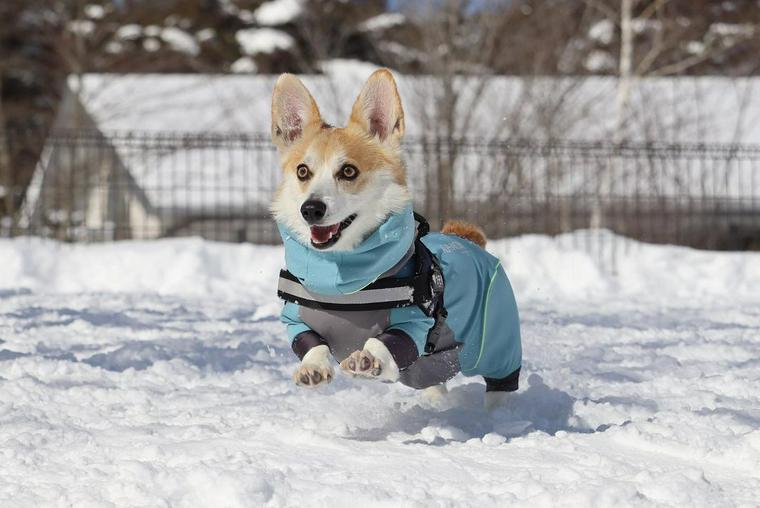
[278,206,522,388]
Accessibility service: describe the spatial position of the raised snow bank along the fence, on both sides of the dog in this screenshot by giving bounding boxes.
[0,233,760,305]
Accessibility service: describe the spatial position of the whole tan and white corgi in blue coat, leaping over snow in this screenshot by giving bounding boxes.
[271,69,521,401]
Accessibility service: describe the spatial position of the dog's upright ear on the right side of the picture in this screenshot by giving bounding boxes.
[349,69,404,142]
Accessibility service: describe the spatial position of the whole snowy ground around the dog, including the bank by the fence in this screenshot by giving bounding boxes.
[0,233,760,508]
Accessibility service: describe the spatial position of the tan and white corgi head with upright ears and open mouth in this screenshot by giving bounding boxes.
[272,69,410,250]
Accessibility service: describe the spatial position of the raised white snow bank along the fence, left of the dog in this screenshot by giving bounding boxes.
[0,238,283,299]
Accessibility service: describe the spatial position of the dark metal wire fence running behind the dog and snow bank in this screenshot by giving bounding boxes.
[0,132,760,249]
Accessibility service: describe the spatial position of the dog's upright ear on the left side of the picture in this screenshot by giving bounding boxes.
[272,74,322,150]
